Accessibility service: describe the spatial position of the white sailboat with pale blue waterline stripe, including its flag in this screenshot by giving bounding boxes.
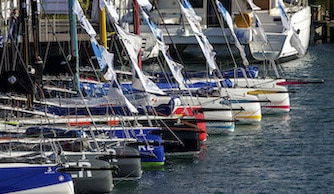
[132,0,234,134]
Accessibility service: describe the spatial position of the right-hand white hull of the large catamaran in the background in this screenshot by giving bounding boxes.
[249,6,311,61]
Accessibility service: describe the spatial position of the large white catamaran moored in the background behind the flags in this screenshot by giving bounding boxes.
[111,0,311,58]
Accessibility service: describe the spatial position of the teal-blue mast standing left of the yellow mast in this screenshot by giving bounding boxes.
[68,0,80,90]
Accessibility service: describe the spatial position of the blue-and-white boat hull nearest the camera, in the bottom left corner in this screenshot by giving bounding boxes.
[0,163,74,194]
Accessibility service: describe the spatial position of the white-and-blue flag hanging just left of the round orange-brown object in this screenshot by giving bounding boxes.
[216,0,249,66]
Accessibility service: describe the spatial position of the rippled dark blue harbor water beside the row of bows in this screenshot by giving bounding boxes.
[112,44,334,194]
